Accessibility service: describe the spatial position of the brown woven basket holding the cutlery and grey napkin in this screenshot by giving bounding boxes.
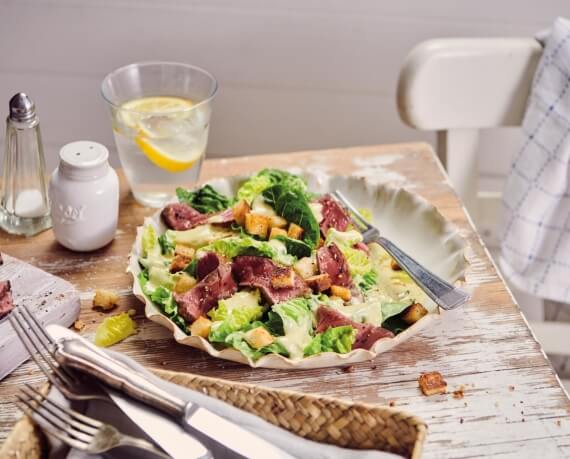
[0,370,427,459]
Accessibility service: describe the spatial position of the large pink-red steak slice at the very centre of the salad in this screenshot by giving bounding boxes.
[232,255,311,304]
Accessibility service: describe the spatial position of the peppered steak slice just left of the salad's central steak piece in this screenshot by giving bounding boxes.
[174,262,237,322]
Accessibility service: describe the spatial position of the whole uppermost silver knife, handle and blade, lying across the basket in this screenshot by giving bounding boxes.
[55,337,292,459]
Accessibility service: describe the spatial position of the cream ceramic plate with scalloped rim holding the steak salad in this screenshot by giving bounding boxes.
[128,172,466,369]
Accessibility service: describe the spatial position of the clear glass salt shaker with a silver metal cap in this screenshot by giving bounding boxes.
[0,92,51,236]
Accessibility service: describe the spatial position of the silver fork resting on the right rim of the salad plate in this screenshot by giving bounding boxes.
[332,190,470,310]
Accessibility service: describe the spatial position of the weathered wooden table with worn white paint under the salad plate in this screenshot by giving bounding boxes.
[0,143,570,458]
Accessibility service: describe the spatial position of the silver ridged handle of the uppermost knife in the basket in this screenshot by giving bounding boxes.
[55,339,186,418]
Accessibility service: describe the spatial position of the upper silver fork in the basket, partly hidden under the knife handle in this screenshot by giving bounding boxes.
[8,305,108,403]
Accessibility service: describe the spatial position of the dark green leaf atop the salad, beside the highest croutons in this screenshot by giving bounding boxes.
[263,184,320,249]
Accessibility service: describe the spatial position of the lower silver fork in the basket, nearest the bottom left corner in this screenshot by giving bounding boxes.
[16,384,168,458]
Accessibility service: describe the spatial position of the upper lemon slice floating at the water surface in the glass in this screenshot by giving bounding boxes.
[120,96,194,130]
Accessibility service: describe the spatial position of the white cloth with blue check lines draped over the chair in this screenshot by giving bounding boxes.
[499,18,570,302]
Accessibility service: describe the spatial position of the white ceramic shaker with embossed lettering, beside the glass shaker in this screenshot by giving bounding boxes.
[49,140,119,252]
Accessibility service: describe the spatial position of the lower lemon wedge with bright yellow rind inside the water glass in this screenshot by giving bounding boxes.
[135,135,204,172]
